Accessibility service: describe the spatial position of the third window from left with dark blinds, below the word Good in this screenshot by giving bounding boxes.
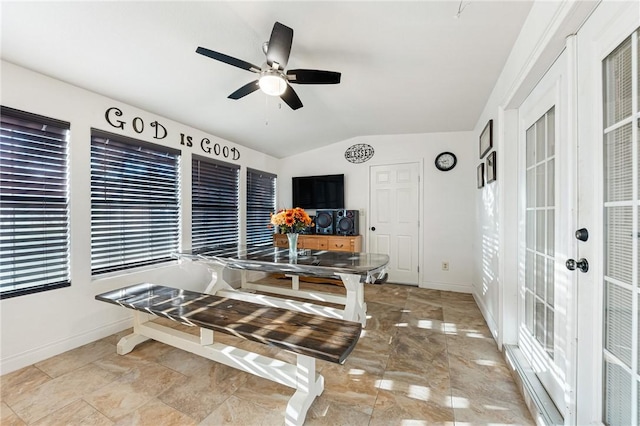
[191,155,240,248]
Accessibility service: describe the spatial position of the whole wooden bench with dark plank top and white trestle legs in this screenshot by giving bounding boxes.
[95,283,362,426]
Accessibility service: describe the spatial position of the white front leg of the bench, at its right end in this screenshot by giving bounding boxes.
[285,355,324,426]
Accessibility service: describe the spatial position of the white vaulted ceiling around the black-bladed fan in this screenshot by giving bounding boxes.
[0,0,531,158]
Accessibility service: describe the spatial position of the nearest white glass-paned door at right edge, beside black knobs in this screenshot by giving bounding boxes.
[575,1,640,425]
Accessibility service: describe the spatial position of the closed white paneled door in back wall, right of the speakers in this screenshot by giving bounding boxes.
[368,163,420,285]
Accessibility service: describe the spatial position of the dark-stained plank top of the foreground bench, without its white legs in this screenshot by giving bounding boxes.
[96,283,362,364]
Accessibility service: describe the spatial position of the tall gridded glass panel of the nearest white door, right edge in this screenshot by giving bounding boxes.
[602,31,640,425]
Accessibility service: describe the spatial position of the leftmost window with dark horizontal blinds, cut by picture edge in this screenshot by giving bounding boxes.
[0,107,70,299]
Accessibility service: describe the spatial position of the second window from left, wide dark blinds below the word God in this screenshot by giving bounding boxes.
[91,130,180,275]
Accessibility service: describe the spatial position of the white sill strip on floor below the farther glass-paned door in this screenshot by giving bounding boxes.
[502,345,564,426]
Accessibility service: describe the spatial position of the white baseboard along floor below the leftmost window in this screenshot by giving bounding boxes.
[0,318,133,375]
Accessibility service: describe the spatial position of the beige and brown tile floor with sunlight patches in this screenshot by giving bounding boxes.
[0,284,533,426]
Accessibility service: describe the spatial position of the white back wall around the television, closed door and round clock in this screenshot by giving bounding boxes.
[278,132,478,293]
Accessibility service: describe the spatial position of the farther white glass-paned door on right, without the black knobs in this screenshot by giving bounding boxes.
[518,47,575,415]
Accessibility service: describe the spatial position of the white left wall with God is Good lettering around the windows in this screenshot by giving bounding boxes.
[0,61,278,374]
